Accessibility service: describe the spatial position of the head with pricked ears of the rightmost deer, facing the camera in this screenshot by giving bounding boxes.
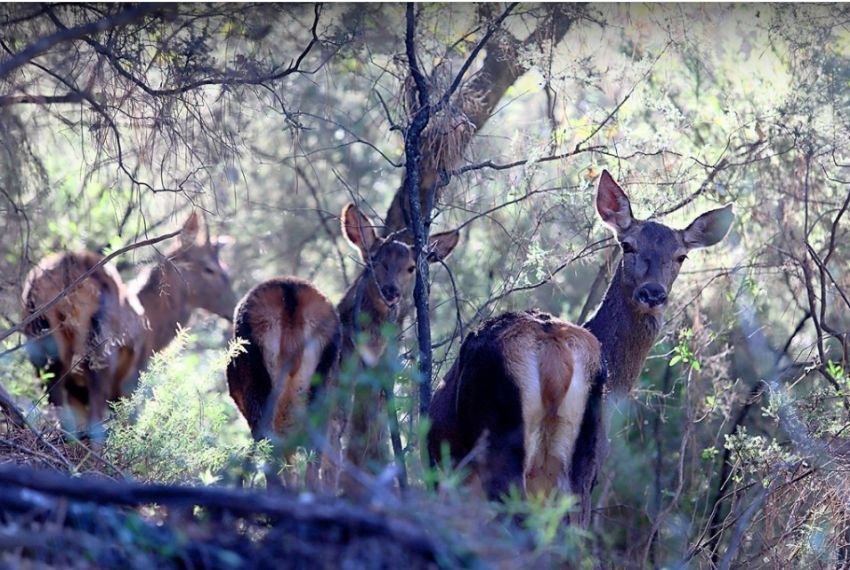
[596,170,735,316]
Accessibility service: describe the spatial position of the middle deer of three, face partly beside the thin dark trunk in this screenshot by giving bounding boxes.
[227,203,459,489]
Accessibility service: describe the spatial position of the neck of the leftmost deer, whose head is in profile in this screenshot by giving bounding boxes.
[136,262,191,354]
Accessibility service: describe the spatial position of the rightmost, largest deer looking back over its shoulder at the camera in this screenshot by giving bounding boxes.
[428,170,734,526]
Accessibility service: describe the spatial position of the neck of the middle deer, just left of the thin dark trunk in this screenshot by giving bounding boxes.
[337,271,394,365]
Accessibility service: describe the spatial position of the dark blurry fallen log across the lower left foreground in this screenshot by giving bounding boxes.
[0,467,470,569]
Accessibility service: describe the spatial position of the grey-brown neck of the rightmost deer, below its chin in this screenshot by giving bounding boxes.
[584,265,661,393]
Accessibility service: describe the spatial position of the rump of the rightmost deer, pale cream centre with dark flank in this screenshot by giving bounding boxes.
[428,311,600,499]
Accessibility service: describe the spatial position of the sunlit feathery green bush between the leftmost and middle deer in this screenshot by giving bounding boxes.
[104,330,253,484]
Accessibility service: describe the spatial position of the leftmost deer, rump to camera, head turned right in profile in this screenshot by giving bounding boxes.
[22,212,236,441]
